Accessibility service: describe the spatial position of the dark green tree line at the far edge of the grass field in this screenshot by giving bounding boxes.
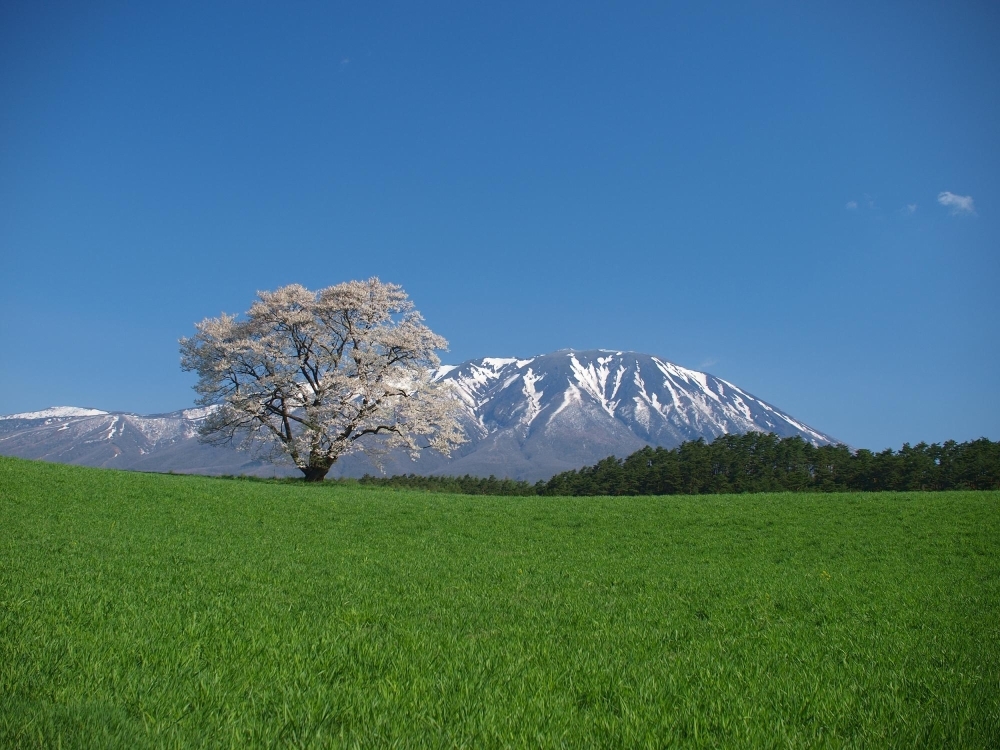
[359,432,1000,496]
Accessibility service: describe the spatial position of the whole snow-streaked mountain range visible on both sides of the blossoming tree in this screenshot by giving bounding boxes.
[0,351,833,480]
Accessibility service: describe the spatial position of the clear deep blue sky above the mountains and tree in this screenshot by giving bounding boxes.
[0,2,1000,449]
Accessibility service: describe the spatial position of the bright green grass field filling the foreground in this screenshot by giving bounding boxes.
[0,458,1000,748]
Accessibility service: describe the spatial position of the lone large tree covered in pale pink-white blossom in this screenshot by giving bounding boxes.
[180,278,465,479]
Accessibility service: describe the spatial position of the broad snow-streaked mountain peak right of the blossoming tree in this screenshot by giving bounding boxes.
[372,350,833,479]
